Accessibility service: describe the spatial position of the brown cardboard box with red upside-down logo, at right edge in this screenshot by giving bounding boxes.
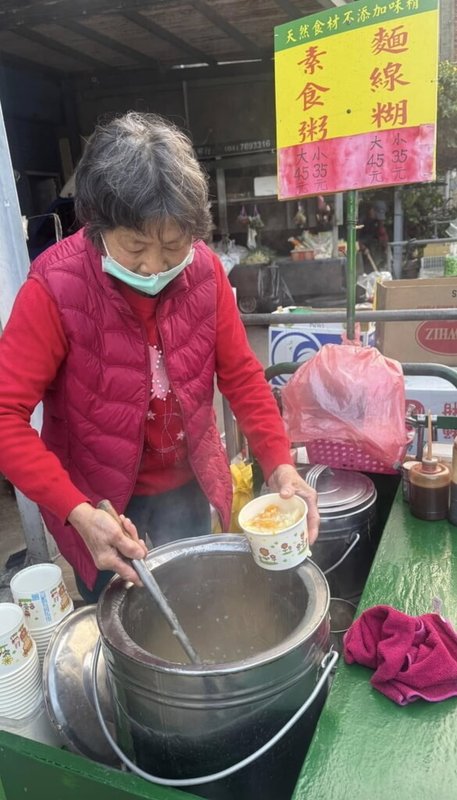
[376,278,457,366]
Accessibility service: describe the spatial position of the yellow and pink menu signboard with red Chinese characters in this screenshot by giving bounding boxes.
[275,0,438,200]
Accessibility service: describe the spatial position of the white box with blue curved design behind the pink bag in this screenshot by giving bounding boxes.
[268,309,375,386]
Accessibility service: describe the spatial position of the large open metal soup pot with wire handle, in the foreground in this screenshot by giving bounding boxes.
[97,534,330,800]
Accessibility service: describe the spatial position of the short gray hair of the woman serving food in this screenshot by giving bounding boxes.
[75,111,212,246]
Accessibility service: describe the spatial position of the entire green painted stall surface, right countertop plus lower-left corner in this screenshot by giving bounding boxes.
[0,493,457,800]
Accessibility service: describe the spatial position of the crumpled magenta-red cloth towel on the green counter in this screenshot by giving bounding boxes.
[344,606,457,706]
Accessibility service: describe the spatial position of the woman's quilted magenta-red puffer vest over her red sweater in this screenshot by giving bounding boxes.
[30,231,232,587]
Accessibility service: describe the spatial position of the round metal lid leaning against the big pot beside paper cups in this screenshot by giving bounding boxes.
[43,605,118,766]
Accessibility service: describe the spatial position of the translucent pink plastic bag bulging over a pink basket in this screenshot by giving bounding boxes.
[282,344,409,472]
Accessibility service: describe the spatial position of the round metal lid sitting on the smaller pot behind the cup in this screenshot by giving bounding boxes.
[299,467,376,514]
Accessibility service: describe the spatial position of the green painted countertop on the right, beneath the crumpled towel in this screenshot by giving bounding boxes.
[293,492,457,800]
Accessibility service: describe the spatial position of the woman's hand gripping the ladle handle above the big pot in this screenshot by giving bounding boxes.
[68,503,147,586]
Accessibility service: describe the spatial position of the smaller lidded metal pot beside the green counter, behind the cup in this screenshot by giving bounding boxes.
[299,467,377,599]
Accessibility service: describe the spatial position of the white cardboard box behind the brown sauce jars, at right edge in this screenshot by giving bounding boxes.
[405,375,457,455]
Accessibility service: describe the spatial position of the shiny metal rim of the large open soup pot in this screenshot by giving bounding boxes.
[97,533,330,676]
